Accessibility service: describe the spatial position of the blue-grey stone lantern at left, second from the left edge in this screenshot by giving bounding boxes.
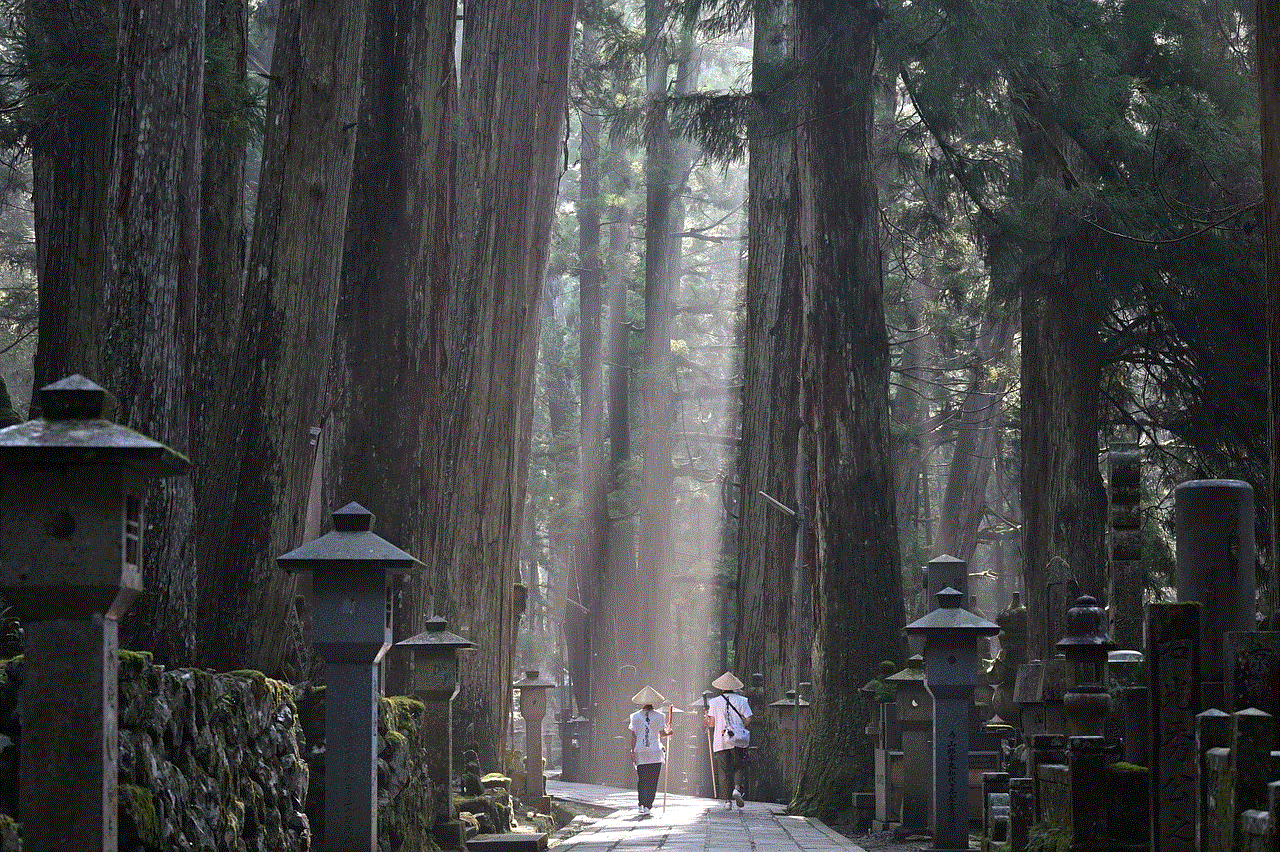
[276,503,422,852]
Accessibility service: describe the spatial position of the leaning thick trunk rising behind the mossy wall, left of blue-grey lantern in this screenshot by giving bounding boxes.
[198,0,376,674]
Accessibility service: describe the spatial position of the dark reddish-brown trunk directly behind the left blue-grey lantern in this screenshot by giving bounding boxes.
[323,0,456,695]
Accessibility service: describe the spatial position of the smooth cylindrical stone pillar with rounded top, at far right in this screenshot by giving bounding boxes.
[1174,480,1257,710]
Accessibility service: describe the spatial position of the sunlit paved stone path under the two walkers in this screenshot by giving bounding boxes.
[547,780,863,852]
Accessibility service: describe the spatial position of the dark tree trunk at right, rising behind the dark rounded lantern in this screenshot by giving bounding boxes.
[1018,96,1107,659]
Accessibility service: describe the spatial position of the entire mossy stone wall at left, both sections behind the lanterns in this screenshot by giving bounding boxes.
[0,651,436,852]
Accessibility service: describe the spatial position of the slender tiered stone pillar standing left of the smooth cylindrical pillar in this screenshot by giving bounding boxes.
[1107,444,1143,651]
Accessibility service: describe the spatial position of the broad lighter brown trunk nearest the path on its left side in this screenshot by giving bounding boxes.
[440,0,573,768]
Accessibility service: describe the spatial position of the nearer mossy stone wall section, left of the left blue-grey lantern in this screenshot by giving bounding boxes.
[0,651,310,852]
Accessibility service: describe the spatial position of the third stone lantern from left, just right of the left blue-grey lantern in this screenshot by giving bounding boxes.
[396,615,475,849]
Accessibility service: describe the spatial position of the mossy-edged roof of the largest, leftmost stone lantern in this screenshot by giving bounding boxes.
[0,375,191,476]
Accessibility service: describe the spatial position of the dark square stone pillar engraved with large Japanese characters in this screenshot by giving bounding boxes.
[1147,603,1201,852]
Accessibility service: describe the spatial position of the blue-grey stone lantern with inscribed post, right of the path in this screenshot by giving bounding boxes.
[904,587,1000,852]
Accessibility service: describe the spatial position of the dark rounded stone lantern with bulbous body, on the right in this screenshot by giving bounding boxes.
[1057,595,1115,737]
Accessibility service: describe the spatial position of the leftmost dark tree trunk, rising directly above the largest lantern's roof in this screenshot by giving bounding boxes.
[23,0,119,399]
